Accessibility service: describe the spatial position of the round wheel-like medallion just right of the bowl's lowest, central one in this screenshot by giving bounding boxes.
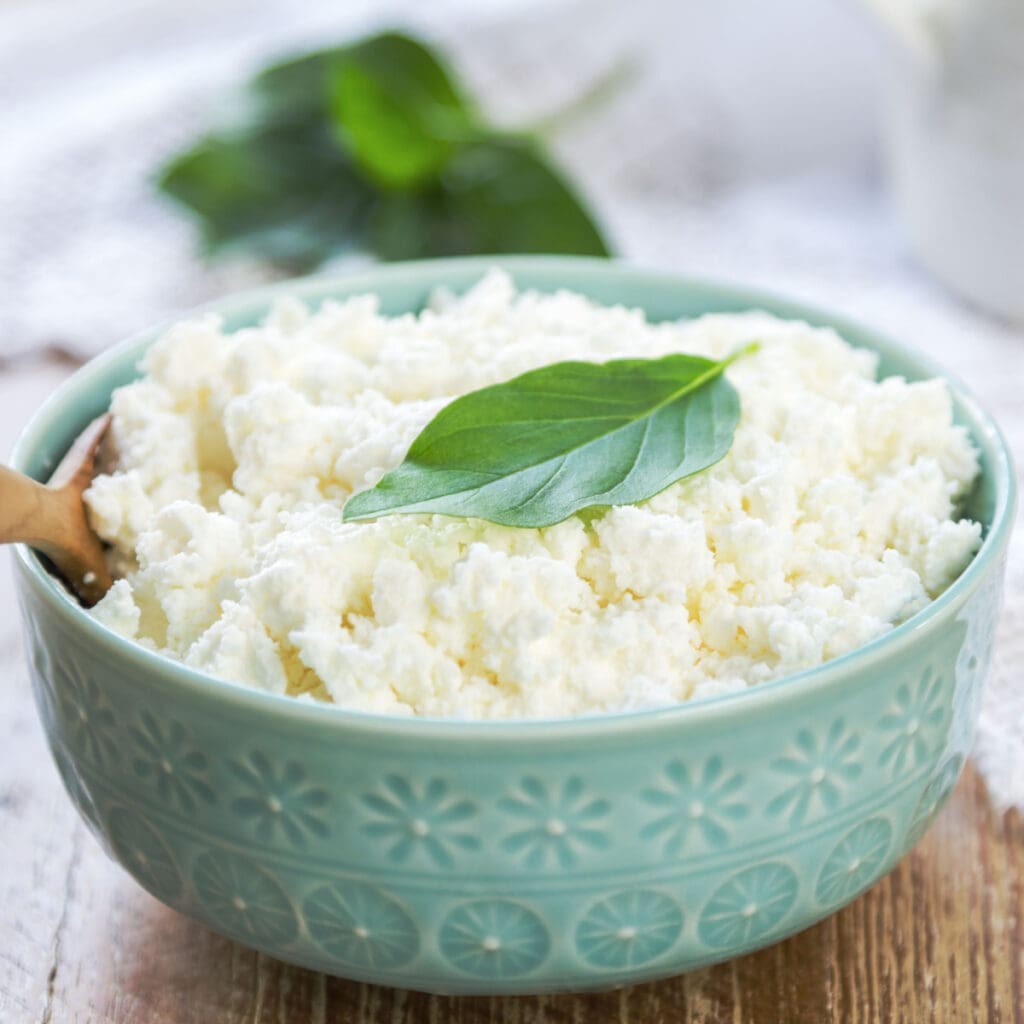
[575,890,683,968]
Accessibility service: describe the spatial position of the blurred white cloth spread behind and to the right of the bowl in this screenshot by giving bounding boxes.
[0,0,1024,809]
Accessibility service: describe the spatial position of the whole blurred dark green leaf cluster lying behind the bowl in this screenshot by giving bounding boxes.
[158,32,611,270]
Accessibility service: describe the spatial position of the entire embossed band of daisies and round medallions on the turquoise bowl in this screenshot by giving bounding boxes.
[24,591,994,990]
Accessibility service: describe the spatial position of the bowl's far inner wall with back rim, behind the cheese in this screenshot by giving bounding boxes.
[13,257,1012,531]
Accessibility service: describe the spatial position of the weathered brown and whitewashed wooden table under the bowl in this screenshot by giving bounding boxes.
[0,364,1024,1024]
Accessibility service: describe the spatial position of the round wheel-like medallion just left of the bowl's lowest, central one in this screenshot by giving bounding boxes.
[302,882,420,970]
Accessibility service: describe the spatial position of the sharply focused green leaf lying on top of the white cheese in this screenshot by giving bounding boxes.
[343,344,757,526]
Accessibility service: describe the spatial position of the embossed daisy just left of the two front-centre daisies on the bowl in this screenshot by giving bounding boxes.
[229,751,331,850]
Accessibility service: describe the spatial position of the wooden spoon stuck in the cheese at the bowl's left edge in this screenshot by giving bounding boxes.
[0,413,112,607]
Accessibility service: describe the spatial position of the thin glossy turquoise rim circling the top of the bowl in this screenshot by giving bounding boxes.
[11,256,1017,741]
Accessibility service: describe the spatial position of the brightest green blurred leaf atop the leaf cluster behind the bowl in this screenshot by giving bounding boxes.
[331,33,476,188]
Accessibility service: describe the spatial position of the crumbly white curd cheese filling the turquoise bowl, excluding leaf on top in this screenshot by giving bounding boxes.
[86,272,980,718]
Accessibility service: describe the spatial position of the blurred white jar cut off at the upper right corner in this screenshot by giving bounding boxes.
[867,0,1024,322]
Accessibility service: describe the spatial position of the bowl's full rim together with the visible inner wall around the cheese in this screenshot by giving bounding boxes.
[12,257,1015,742]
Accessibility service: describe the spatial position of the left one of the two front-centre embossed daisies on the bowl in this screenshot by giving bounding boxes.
[360,775,480,867]
